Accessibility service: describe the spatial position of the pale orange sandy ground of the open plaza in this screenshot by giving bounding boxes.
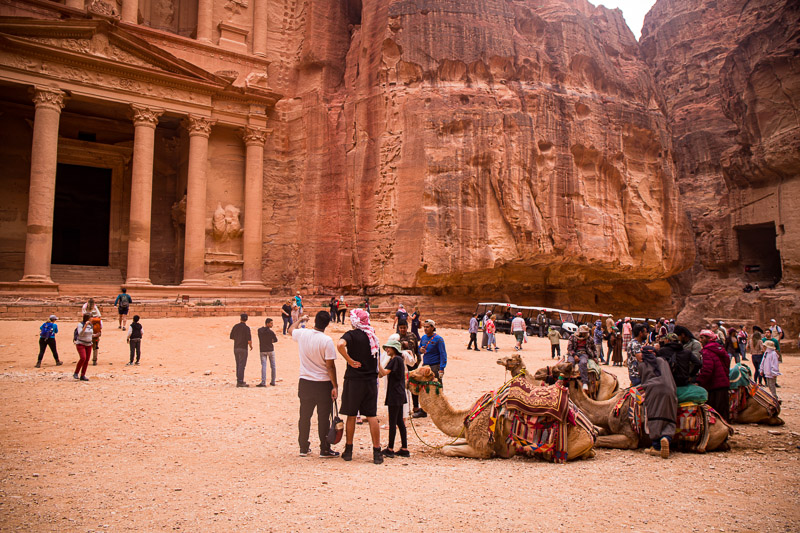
[0,318,800,531]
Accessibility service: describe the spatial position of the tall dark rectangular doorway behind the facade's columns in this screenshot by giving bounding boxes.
[51,163,111,266]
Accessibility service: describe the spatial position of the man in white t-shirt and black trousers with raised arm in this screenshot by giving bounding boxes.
[289,311,339,458]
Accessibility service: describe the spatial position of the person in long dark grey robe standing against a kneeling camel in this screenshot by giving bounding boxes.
[636,346,678,459]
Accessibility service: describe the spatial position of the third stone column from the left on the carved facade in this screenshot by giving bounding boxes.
[181,115,215,285]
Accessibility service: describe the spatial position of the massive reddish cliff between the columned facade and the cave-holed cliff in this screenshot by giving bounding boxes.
[264,0,693,308]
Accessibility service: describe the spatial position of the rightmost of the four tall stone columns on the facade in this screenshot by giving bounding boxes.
[242,126,269,286]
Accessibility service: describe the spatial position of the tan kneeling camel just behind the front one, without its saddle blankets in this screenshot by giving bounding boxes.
[534,363,733,451]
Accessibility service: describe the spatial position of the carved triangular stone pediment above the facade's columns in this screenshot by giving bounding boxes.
[0,18,227,87]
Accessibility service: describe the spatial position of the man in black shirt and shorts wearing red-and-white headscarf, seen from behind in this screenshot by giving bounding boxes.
[336,309,383,464]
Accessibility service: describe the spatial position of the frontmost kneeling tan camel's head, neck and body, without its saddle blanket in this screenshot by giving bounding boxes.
[406,366,595,461]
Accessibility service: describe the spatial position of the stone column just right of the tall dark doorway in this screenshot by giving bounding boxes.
[126,104,164,285]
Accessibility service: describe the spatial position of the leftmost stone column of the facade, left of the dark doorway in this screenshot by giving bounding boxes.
[22,87,64,283]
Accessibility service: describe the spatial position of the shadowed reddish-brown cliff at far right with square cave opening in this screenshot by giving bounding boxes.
[641,0,800,327]
